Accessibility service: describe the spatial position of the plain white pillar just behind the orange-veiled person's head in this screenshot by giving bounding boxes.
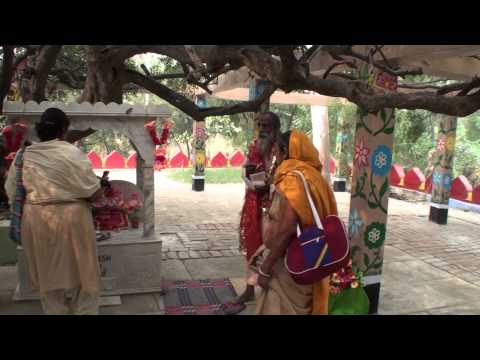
[310,105,330,184]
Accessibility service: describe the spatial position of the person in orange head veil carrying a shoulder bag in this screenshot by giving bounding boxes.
[256,130,337,315]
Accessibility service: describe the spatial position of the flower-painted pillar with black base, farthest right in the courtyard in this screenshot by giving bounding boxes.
[429,115,457,225]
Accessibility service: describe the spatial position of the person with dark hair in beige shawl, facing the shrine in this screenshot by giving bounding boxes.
[5,108,101,314]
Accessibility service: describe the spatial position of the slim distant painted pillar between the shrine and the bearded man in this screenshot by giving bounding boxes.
[192,96,208,191]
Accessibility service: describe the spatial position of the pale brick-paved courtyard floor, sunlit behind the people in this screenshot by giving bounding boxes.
[0,171,480,314]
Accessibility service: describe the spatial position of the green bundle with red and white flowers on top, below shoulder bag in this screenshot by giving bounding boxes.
[328,260,370,315]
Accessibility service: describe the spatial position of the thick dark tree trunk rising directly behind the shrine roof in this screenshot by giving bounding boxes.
[80,46,125,104]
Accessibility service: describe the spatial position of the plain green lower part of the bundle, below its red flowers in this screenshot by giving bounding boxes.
[328,287,370,315]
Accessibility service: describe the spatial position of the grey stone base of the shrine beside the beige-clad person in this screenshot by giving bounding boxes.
[14,229,162,301]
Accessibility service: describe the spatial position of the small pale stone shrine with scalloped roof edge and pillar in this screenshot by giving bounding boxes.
[3,101,170,300]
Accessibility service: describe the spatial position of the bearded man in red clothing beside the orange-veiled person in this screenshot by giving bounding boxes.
[224,112,280,314]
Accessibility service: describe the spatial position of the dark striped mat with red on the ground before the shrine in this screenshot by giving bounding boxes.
[163,279,244,315]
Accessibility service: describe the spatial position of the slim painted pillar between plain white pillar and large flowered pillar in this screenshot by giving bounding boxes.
[333,118,350,192]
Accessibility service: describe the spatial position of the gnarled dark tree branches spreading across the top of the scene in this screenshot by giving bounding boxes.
[0,45,480,121]
